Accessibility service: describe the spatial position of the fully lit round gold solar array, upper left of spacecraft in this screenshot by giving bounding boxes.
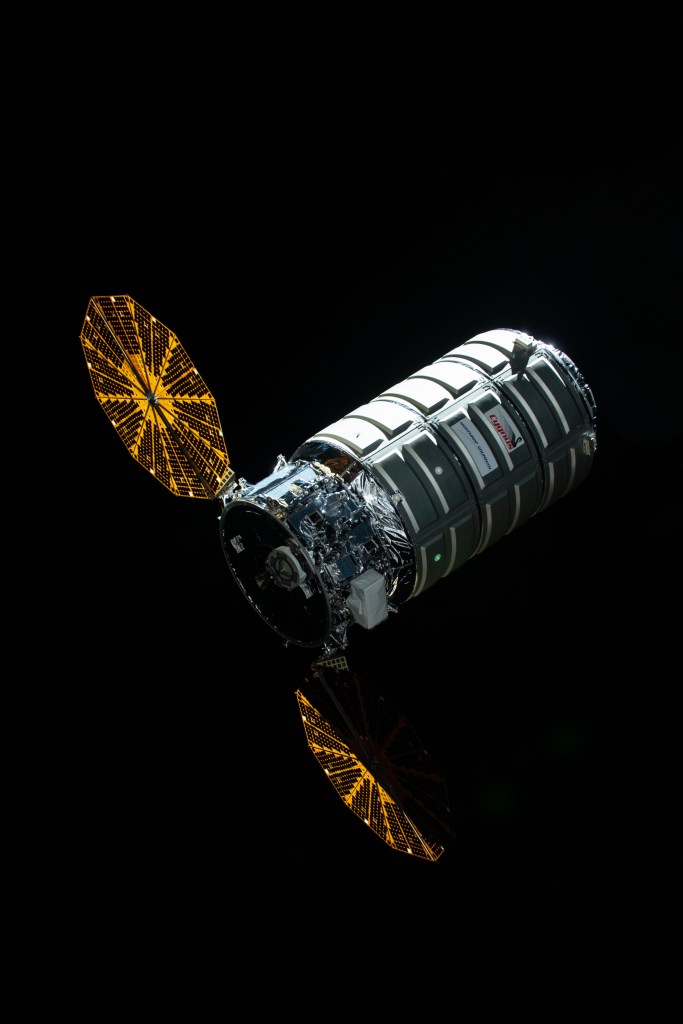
[81,295,234,499]
